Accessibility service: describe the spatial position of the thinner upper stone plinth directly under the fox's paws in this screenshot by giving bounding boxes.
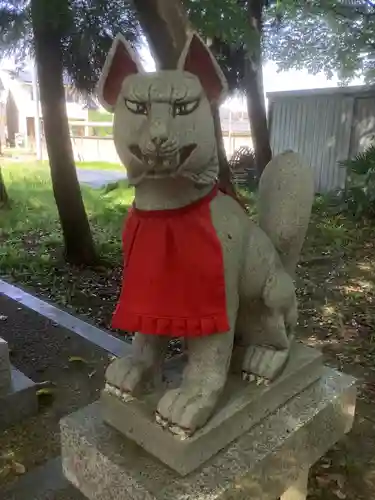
[101,344,323,475]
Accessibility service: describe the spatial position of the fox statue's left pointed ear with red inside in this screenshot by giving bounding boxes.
[97,35,143,112]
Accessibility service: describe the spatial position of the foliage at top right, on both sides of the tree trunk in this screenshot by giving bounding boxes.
[185,0,375,85]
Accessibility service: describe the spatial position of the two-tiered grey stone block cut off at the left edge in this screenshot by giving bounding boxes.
[0,338,38,429]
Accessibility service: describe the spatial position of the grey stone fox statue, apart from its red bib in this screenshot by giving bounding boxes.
[98,32,314,433]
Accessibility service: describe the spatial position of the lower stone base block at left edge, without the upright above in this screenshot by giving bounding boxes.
[0,367,38,429]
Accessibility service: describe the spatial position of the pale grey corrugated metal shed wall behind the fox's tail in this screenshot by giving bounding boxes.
[271,95,353,192]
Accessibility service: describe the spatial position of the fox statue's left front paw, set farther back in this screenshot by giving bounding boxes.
[105,357,150,401]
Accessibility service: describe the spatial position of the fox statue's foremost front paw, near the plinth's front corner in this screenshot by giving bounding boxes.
[156,387,221,438]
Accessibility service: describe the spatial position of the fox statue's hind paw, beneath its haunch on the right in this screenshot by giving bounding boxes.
[242,346,289,385]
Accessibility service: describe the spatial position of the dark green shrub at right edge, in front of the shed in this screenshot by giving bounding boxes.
[340,144,375,217]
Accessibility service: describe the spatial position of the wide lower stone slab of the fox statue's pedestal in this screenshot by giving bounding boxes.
[61,368,356,500]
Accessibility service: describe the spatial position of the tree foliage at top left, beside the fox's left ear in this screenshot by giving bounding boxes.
[0,0,140,93]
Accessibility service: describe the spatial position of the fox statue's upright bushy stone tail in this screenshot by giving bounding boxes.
[258,151,314,277]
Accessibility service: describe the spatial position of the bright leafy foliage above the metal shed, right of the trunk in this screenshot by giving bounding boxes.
[264,0,375,83]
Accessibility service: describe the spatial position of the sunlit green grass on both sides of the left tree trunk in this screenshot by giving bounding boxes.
[0,164,133,282]
